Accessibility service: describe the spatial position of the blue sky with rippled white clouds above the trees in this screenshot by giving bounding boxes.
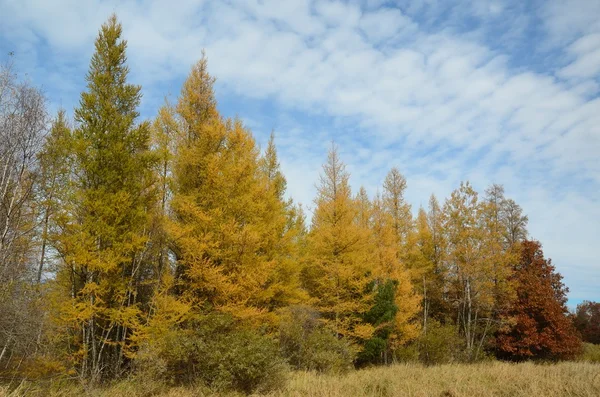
[0,0,600,306]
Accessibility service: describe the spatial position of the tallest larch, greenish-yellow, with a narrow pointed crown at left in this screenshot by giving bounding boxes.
[51,15,154,379]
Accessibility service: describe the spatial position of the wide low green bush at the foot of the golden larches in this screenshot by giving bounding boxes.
[136,314,287,393]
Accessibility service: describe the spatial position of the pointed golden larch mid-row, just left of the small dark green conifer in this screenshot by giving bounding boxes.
[303,145,374,342]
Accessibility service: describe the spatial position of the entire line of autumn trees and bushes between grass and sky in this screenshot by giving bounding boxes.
[0,16,598,391]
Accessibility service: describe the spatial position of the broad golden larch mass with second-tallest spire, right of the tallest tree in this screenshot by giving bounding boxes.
[169,57,303,322]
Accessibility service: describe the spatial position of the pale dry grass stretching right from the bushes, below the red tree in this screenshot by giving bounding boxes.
[277,362,600,397]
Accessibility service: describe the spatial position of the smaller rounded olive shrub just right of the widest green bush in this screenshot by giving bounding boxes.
[279,306,354,372]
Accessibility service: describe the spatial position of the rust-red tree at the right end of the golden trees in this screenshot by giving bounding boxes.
[496,241,581,361]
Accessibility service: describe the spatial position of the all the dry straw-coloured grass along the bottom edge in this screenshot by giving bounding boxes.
[0,362,600,397]
